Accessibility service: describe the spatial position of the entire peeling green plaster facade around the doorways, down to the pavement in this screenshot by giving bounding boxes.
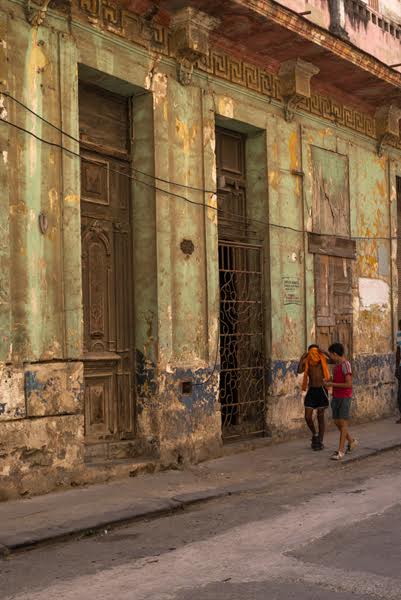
[0,3,400,495]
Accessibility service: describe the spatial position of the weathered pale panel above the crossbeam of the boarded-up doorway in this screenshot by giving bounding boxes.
[312,146,350,236]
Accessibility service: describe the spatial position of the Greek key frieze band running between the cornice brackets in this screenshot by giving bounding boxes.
[64,0,401,150]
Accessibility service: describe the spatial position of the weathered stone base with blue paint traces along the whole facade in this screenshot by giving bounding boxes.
[0,354,397,500]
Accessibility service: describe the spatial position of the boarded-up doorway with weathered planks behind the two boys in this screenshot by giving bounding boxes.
[309,146,356,358]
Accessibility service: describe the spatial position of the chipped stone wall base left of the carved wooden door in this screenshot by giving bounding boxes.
[0,362,84,500]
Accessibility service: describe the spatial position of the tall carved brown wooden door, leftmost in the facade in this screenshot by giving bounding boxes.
[80,82,135,441]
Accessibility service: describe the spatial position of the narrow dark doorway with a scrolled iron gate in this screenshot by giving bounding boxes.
[216,128,266,440]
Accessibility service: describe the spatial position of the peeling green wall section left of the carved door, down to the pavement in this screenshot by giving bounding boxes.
[0,3,83,499]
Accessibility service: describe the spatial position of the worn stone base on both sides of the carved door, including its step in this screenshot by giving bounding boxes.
[0,362,222,500]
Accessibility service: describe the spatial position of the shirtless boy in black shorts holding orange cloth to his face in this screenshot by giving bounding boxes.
[298,344,330,450]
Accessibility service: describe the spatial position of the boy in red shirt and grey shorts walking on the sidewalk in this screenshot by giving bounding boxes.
[324,342,358,460]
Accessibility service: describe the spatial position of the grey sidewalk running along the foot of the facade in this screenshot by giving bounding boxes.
[0,419,401,556]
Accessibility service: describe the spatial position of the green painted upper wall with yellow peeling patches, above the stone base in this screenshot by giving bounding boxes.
[0,3,400,454]
